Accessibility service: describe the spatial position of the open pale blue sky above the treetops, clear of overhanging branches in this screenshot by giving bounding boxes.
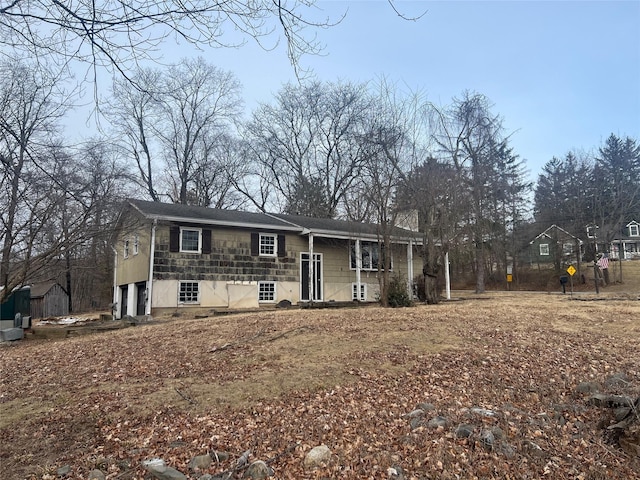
[180,0,640,184]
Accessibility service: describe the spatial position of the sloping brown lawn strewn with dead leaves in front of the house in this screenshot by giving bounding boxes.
[0,293,640,479]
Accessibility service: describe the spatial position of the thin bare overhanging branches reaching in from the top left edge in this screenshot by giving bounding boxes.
[0,0,340,80]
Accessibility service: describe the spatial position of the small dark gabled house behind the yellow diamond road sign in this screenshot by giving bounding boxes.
[529,225,583,270]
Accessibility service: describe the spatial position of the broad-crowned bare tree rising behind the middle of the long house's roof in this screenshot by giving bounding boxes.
[247,82,371,217]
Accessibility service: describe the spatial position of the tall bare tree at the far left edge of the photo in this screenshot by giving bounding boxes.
[0,63,71,299]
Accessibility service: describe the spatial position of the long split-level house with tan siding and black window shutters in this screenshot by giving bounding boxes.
[114,200,422,318]
